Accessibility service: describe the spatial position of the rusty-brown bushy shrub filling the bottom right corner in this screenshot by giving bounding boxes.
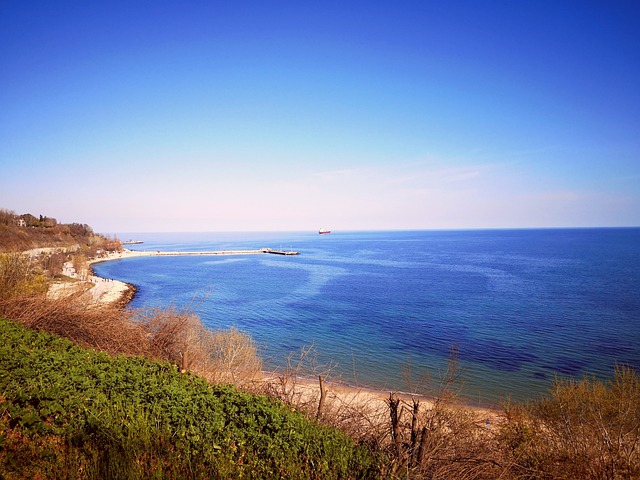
[502,367,640,480]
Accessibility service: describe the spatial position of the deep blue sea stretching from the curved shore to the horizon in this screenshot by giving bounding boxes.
[94,228,640,406]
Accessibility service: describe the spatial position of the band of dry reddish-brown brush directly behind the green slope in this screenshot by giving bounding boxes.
[0,292,262,386]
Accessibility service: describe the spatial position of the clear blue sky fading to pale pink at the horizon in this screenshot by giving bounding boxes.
[0,0,640,233]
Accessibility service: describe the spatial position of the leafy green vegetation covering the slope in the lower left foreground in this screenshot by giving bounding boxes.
[0,319,378,479]
